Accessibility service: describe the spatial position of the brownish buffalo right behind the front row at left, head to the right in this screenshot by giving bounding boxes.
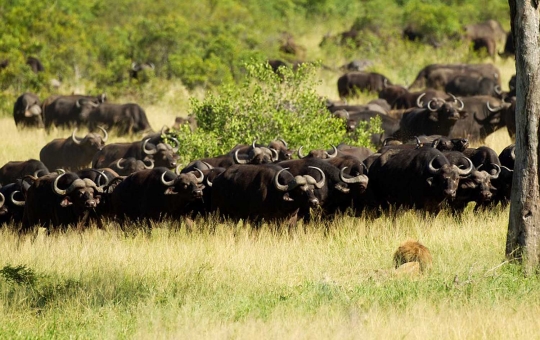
[39,128,108,170]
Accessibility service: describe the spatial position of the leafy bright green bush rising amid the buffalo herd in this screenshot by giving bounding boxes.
[171,63,380,162]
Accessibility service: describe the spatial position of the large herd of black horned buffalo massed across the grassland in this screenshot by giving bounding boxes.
[0,53,515,233]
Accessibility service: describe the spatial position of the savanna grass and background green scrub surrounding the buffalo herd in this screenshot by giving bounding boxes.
[0,0,540,339]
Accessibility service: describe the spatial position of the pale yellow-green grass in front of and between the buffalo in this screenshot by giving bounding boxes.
[0,44,524,339]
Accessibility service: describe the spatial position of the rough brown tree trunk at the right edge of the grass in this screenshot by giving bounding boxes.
[506,0,540,272]
